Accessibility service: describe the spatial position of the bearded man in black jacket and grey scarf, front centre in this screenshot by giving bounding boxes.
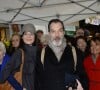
[36,19,83,90]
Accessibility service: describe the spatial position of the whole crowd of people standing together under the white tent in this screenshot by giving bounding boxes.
[0,19,100,90]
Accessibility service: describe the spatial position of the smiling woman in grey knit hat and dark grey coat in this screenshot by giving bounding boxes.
[0,24,37,90]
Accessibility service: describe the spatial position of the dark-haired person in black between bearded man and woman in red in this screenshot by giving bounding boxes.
[65,36,89,90]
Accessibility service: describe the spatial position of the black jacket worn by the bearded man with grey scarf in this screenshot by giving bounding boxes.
[36,46,74,90]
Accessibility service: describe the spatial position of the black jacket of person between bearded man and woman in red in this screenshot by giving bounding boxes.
[76,48,89,90]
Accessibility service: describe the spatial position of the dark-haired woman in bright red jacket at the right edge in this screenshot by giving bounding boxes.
[84,37,100,90]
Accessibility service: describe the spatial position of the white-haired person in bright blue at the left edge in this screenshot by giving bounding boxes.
[0,42,22,90]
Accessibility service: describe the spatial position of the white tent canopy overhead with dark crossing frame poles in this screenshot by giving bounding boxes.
[0,0,100,25]
